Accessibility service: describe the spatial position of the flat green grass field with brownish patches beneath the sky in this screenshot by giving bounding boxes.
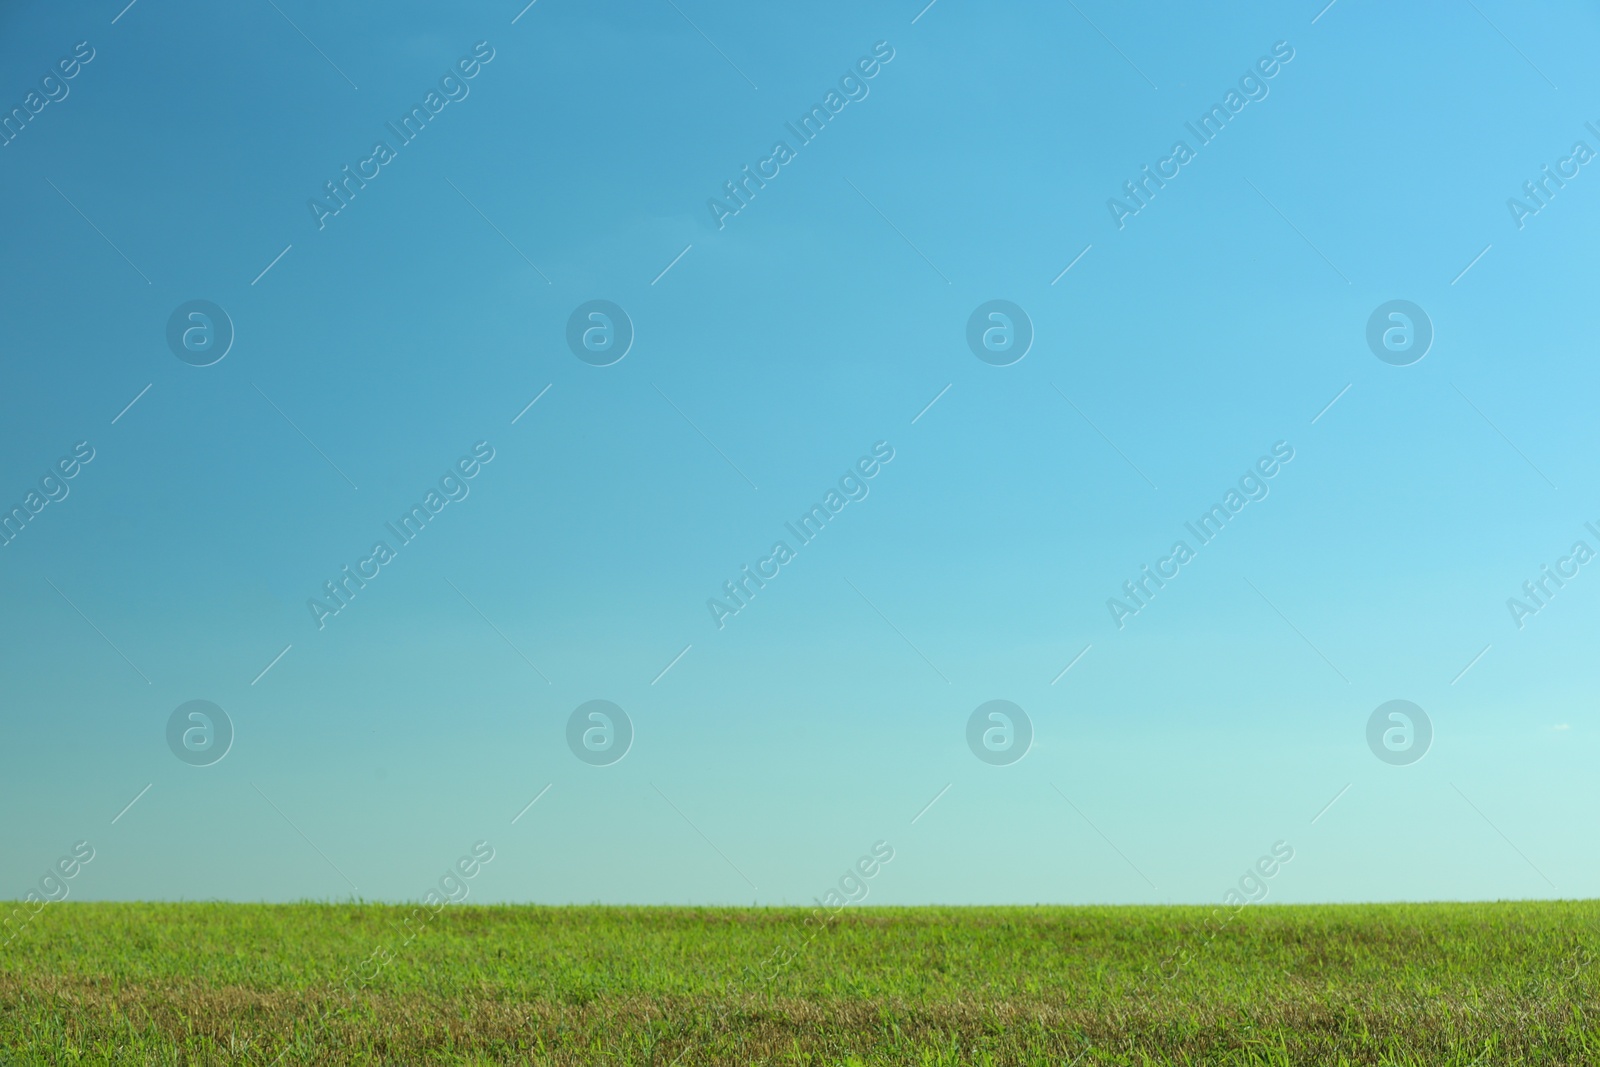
[0,902,1600,1067]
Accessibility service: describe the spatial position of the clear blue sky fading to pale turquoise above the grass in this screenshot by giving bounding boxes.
[0,0,1600,904]
